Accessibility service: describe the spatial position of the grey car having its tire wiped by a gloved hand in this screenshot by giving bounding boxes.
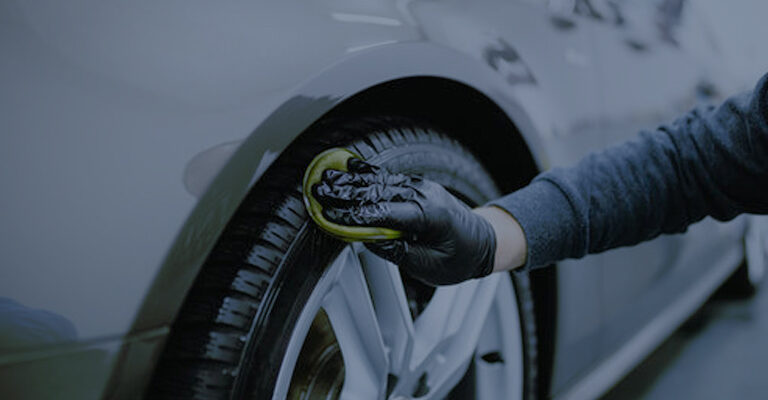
[0,0,767,400]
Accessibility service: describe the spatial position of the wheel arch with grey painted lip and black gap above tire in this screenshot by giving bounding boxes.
[112,44,560,392]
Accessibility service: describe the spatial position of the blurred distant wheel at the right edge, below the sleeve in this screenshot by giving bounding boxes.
[723,216,768,298]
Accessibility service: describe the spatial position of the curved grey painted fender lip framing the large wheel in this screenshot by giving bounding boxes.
[132,42,546,331]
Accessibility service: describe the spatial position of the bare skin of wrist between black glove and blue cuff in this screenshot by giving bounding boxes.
[472,206,528,272]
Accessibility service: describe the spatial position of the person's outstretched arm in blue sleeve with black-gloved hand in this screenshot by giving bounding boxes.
[312,76,768,285]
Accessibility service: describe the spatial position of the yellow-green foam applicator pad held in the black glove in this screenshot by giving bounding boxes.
[302,148,402,242]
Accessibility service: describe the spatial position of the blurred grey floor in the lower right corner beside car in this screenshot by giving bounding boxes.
[603,285,768,400]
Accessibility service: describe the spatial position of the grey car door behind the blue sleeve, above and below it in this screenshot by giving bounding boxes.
[585,0,733,357]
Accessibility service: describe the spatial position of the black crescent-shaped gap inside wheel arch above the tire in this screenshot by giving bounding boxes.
[326,77,538,193]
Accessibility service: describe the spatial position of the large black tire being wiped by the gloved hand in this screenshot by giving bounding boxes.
[147,117,536,399]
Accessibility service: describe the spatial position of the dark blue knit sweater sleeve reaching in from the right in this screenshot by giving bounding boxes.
[490,75,768,269]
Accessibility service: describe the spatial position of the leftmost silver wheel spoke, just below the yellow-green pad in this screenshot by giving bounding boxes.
[322,247,389,399]
